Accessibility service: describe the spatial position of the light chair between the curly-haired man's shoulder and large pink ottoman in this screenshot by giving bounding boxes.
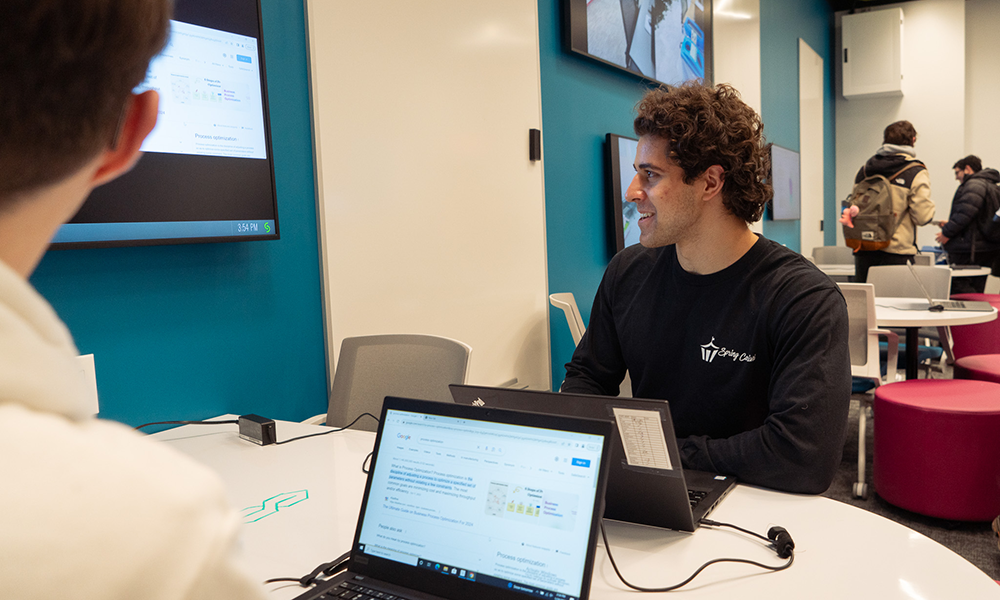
[838,283,899,498]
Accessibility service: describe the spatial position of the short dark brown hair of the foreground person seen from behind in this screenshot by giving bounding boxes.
[0,0,173,208]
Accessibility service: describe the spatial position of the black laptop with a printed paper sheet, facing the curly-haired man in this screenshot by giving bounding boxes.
[448,385,736,531]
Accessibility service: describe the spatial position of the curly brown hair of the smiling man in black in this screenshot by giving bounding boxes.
[634,81,772,223]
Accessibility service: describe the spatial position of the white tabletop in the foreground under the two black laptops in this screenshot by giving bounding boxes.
[155,416,1000,600]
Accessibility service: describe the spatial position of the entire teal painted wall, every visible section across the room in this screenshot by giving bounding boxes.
[25,0,835,425]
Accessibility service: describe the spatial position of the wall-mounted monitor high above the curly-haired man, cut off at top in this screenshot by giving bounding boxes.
[564,0,713,85]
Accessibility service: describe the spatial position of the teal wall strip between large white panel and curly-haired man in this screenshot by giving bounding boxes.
[538,0,647,389]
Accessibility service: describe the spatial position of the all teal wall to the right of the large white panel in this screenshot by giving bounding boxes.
[538,0,835,388]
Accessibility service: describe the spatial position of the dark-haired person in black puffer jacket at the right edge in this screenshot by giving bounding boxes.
[936,154,1000,294]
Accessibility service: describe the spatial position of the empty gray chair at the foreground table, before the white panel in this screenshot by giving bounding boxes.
[304,334,472,431]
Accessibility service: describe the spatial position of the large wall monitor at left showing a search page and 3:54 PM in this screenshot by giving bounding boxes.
[53,0,278,248]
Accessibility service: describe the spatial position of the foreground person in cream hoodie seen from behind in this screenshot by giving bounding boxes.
[0,0,263,600]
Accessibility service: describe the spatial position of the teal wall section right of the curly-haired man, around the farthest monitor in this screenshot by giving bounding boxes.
[760,0,837,252]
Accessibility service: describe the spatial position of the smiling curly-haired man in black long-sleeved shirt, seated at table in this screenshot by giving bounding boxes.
[562,83,851,494]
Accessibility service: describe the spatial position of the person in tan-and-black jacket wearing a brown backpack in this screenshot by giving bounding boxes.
[842,121,934,283]
